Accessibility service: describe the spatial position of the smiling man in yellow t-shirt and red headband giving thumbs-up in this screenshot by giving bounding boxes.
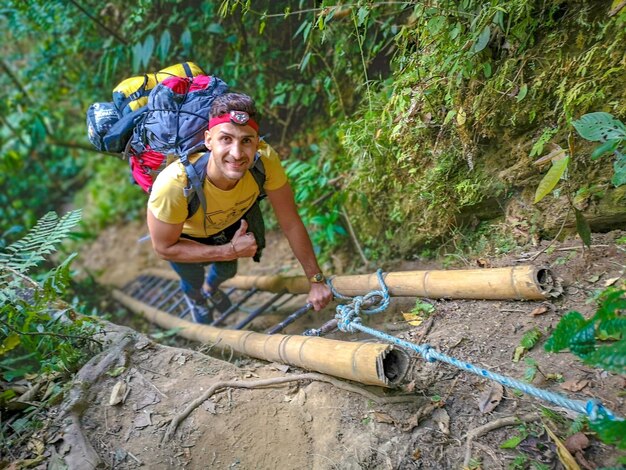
[148,93,332,323]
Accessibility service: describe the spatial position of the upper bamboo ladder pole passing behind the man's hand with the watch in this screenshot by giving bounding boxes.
[140,265,562,300]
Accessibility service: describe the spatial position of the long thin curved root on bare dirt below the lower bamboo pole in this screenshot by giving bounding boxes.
[161,373,415,442]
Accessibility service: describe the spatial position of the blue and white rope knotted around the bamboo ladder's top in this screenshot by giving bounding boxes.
[329,269,623,421]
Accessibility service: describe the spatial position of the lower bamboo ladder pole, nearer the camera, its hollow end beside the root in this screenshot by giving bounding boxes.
[113,290,409,387]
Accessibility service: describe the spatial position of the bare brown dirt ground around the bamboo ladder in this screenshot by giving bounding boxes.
[56,219,626,469]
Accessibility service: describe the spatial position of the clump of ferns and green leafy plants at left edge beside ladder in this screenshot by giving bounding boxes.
[0,211,94,381]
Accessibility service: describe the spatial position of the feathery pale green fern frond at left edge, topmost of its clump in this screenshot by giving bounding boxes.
[0,210,81,274]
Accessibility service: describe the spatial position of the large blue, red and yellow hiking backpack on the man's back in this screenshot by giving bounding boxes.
[87,62,265,233]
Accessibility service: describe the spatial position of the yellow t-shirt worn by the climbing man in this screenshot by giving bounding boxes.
[148,141,287,238]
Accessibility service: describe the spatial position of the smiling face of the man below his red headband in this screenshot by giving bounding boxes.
[204,122,259,190]
